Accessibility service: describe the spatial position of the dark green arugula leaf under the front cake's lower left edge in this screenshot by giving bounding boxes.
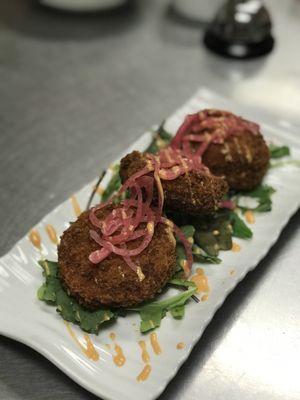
[38,260,117,334]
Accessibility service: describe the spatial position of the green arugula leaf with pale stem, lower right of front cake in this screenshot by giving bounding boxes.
[132,282,197,333]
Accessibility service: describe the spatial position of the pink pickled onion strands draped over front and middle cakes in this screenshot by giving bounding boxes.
[89,148,196,280]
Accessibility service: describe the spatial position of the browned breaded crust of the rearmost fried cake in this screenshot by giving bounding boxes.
[202,131,270,190]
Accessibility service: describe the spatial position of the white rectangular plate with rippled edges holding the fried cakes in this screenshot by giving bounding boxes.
[0,89,300,400]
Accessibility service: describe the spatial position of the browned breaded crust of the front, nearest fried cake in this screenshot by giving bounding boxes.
[58,207,176,309]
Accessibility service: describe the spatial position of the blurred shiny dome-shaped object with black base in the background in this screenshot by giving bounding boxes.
[204,0,274,59]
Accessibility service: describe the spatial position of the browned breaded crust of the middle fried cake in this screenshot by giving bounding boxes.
[120,151,228,215]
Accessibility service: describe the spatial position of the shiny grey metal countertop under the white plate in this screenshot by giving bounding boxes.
[0,0,300,400]
